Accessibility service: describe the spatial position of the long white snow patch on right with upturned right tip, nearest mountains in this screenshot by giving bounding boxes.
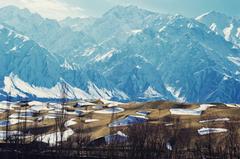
[170,104,215,116]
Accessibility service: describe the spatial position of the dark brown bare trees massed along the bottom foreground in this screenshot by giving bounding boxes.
[0,115,240,159]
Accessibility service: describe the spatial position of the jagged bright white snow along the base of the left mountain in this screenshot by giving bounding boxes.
[3,73,128,100]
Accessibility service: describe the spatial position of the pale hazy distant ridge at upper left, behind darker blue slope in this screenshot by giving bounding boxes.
[0,6,94,57]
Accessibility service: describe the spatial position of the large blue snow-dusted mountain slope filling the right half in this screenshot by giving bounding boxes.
[82,10,240,102]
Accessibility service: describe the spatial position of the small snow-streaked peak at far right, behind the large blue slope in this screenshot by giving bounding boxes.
[196,11,240,47]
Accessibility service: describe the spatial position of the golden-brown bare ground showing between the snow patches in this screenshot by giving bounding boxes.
[0,101,240,142]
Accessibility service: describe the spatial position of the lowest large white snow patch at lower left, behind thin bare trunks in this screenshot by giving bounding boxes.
[37,129,74,146]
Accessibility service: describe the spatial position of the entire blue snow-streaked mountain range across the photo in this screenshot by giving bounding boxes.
[0,6,240,103]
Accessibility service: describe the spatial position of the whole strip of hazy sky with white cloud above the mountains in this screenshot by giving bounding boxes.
[0,0,240,19]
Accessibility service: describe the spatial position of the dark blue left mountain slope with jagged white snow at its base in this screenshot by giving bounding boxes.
[0,25,128,102]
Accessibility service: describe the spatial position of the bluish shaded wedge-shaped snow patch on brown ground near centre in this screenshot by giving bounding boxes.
[108,115,148,127]
